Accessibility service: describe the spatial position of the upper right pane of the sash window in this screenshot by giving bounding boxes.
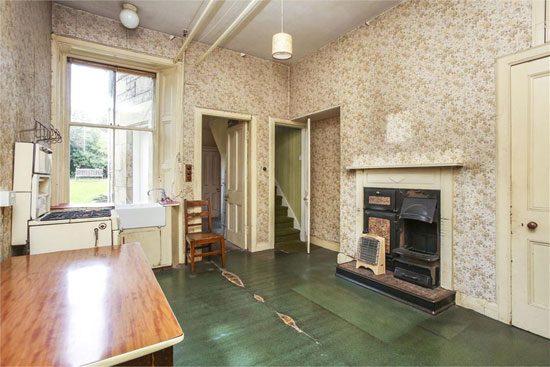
[116,72,155,128]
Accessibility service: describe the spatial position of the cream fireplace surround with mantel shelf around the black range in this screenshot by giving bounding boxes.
[348,163,462,290]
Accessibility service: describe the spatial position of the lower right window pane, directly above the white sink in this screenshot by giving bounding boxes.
[114,130,153,204]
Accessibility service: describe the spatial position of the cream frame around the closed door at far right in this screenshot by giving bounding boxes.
[496,43,550,324]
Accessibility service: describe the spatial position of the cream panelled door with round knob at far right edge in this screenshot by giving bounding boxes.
[511,57,550,338]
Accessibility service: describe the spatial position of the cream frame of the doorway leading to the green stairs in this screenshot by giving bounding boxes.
[268,117,311,249]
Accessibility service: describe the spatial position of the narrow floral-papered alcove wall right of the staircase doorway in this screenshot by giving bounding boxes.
[310,117,340,243]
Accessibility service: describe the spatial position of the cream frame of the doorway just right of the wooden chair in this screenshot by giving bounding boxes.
[193,107,261,252]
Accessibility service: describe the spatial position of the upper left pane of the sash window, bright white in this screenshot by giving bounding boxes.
[70,63,115,124]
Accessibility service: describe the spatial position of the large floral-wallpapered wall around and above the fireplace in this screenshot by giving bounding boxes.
[290,0,531,301]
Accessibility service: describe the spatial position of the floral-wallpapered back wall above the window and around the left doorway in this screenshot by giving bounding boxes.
[52,4,289,246]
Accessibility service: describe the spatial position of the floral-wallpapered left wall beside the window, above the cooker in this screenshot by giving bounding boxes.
[0,1,52,261]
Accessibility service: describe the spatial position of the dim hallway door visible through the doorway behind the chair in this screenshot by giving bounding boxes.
[201,147,221,218]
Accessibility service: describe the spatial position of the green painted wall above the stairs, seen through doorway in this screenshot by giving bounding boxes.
[275,126,302,222]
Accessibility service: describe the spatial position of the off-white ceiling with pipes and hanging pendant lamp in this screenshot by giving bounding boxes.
[56,0,401,63]
